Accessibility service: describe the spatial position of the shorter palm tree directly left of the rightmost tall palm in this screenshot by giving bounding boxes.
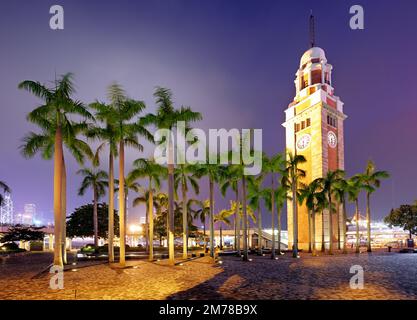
[129,158,166,261]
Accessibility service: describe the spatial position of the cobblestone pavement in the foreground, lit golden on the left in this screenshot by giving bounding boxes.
[0,253,417,299]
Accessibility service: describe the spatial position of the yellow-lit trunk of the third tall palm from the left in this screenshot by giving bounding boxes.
[119,140,126,267]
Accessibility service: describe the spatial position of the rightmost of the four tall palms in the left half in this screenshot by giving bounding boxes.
[140,87,202,264]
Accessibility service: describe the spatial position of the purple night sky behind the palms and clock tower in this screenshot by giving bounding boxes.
[0,0,417,228]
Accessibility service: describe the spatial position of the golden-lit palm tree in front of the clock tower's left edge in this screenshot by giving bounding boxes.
[282,152,307,258]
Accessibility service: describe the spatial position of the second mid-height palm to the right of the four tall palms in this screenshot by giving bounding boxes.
[194,163,226,259]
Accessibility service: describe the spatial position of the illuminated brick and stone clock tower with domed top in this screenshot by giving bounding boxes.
[283,44,346,250]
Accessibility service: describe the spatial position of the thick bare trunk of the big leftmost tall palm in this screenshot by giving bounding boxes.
[53,126,63,267]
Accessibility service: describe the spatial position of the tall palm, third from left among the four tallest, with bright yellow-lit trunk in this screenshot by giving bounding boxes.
[106,83,153,266]
